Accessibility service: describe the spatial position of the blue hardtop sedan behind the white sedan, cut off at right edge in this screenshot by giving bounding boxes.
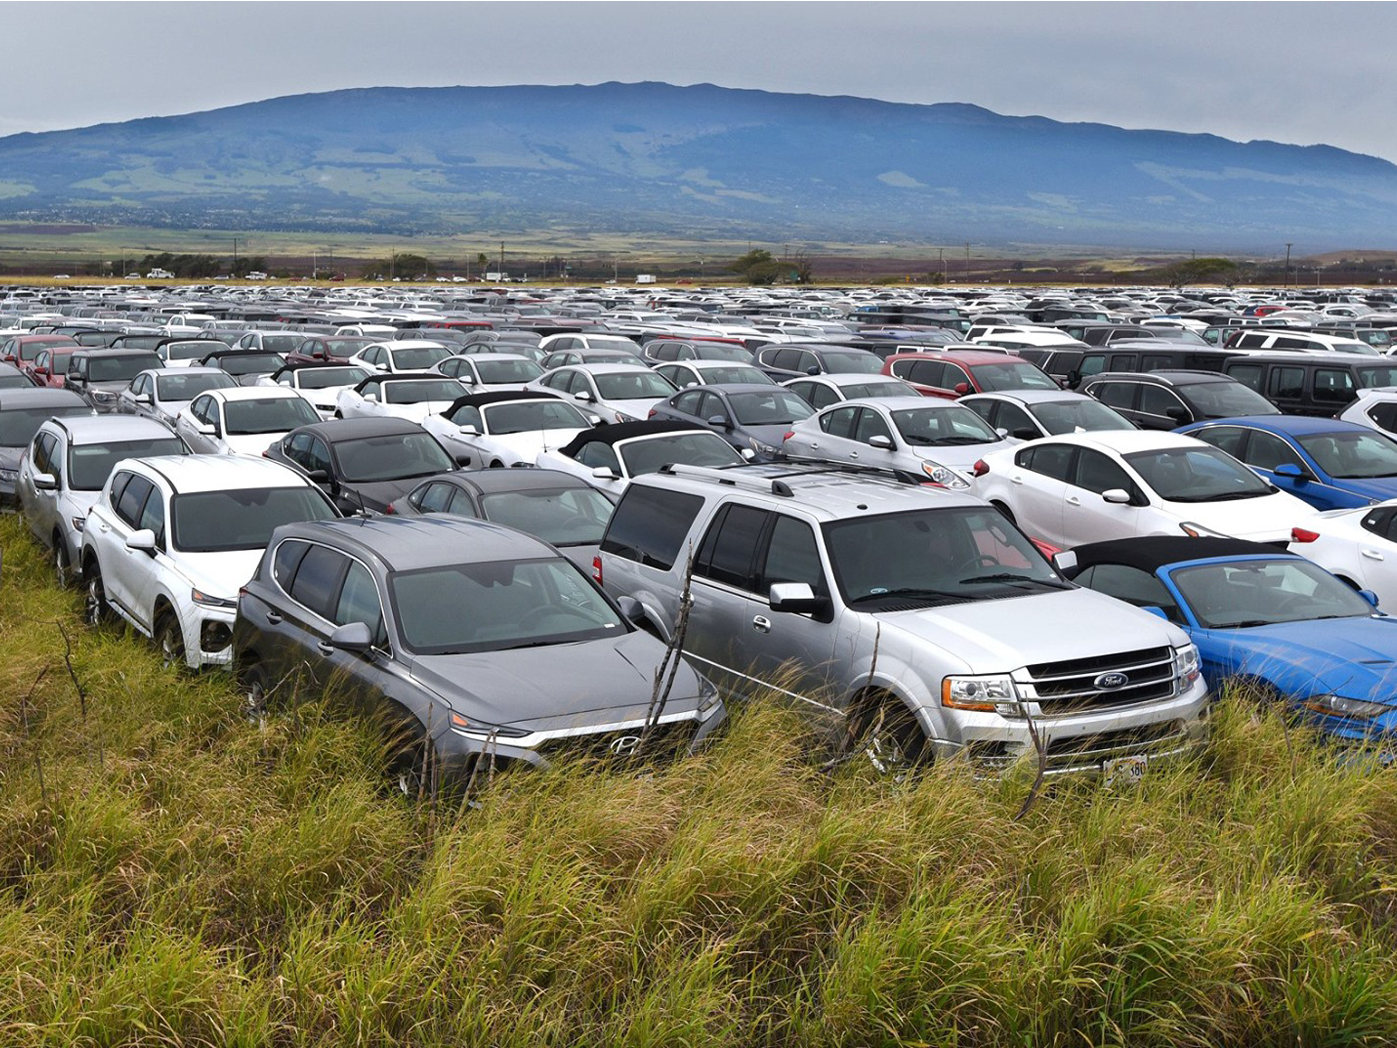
[1175,415,1397,510]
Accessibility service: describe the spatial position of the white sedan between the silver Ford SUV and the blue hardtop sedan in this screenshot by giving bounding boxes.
[971,430,1315,549]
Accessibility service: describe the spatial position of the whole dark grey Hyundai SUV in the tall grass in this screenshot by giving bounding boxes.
[233,516,726,795]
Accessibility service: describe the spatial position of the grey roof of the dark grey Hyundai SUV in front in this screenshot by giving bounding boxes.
[277,513,562,572]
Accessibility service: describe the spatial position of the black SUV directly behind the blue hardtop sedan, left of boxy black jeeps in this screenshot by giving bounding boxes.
[1080,372,1281,429]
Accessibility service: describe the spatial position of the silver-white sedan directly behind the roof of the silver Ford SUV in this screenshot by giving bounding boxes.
[781,394,1018,489]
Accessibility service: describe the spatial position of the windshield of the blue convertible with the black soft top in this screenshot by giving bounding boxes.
[1171,560,1373,629]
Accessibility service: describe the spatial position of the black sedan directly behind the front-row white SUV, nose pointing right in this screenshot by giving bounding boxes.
[263,418,457,514]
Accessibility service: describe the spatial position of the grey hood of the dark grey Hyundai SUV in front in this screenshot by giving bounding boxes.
[412,630,699,731]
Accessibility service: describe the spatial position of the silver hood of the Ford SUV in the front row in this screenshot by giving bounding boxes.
[875,590,1186,674]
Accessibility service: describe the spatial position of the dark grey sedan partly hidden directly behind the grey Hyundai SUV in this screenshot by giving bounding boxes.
[387,470,615,570]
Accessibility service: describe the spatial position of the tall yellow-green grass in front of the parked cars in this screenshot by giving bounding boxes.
[8,517,1397,1048]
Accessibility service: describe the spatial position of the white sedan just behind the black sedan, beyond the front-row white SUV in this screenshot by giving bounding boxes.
[175,386,320,456]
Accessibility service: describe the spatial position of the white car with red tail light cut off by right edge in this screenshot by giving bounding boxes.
[1291,499,1397,609]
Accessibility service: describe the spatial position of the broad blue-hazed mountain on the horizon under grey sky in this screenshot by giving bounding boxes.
[0,84,1397,252]
